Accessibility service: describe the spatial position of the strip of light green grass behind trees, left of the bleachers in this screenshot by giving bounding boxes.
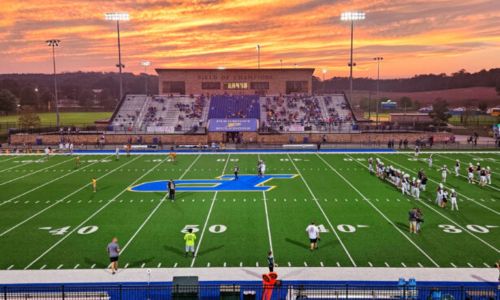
[0,112,113,126]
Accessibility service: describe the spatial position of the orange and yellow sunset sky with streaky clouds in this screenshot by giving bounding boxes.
[0,0,500,78]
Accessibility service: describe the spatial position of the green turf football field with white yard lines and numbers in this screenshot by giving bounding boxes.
[0,153,500,269]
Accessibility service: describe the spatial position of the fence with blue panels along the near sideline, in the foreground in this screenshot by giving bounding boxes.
[0,283,500,300]
